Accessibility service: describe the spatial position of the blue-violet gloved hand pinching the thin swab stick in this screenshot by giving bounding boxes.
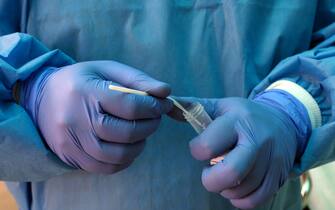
[20,61,172,173]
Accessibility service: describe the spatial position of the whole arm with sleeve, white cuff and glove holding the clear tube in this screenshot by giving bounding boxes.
[170,18,335,208]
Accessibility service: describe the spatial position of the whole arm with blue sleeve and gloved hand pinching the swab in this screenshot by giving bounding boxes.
[0,33,172,181]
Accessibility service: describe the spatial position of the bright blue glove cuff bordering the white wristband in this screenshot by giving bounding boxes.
[253,86,312,160]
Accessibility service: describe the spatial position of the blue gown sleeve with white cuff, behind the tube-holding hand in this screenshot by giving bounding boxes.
[251,24,335,174]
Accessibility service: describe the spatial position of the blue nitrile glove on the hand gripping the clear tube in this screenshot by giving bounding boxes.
[169,90,311,209]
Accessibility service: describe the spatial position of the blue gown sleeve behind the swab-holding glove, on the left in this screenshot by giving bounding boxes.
[0,32,73,181]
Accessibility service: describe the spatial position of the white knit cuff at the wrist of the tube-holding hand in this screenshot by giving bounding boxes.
[266,80,322,129]
